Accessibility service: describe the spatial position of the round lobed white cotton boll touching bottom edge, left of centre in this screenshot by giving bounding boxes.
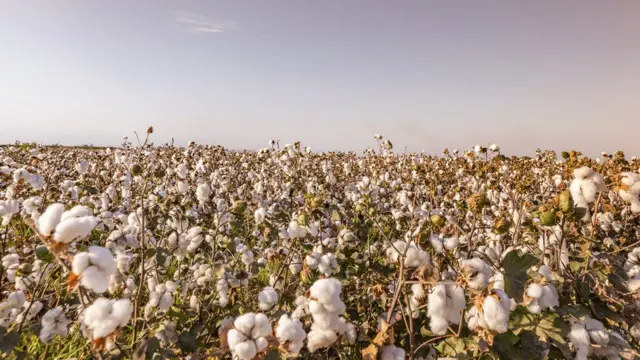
[227,313,272,360]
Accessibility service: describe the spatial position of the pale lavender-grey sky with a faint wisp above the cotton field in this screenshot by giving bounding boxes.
[0,0,640,155]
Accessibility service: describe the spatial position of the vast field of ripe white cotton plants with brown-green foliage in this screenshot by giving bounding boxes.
[0,133,640,360]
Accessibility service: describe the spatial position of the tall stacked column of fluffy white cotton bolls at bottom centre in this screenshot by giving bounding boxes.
[307,278,357,353]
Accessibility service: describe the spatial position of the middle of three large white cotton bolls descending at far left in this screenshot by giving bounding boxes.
[71,246,117,294]
